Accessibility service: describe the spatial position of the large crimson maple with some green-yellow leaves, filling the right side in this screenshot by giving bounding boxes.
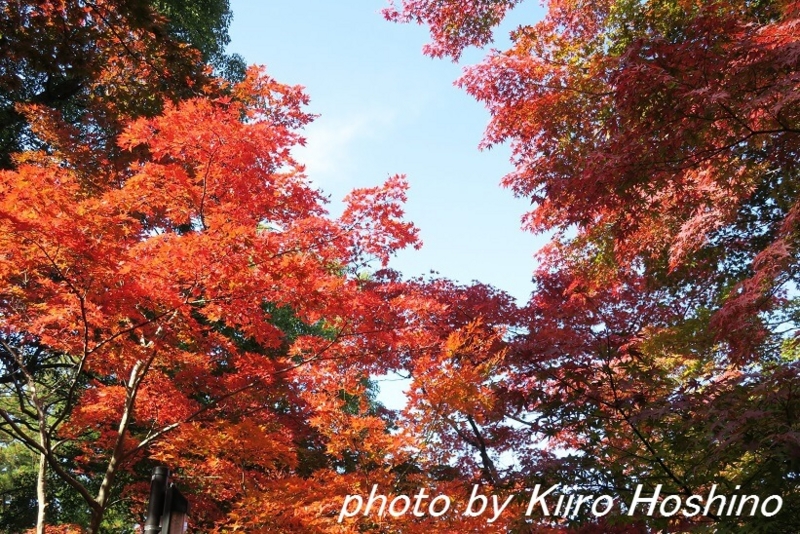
[385,0,800,531]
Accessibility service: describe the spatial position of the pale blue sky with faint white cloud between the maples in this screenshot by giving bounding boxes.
[229,0,544,302]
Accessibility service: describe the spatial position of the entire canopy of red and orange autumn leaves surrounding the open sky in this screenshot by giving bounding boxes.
[0,0,800,533]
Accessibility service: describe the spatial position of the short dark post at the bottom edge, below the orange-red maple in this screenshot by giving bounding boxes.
[144,467,189,534]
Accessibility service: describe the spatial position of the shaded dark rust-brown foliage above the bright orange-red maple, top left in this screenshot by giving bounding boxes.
[0,0,244,169]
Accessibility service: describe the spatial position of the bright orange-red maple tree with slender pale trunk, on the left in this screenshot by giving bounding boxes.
[0,57,444,532]
